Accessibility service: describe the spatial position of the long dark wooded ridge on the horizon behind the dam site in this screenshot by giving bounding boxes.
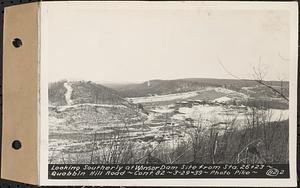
[105,78,288,97]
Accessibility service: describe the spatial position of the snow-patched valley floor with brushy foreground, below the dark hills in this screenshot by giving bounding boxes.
[49,84,289,164]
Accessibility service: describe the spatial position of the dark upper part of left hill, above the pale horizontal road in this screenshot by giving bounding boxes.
[48,81,129,105]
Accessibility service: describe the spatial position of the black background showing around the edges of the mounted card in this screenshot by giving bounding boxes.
[0,0,300,188]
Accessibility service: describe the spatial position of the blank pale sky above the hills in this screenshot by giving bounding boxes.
[42,3,290,83]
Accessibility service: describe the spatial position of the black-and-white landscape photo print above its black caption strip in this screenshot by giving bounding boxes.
[38,2,296,187]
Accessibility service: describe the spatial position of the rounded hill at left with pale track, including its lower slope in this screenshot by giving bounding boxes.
[48,81,147,136]
